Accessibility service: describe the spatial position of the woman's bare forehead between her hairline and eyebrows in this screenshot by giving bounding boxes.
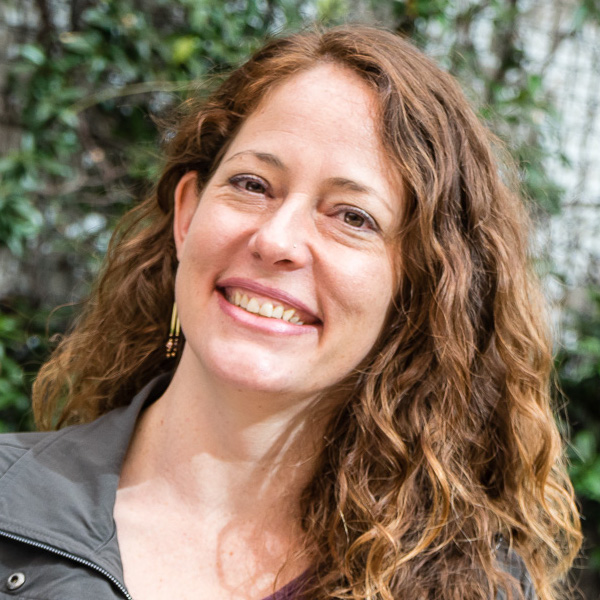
[223,63,402,204]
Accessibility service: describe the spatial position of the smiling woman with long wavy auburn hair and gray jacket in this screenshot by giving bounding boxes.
[0,26,580,600]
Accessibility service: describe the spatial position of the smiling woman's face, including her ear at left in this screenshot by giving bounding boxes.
[175,64,401,397]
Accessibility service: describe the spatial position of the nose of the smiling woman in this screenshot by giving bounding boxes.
[248,195,312,269]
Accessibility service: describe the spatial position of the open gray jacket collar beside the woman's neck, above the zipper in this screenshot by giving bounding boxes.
[0,374,171,580]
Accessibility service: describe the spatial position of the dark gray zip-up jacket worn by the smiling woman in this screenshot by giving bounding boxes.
[0,375,535,600]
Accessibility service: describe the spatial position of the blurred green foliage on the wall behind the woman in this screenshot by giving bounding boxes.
[0,0,600,592]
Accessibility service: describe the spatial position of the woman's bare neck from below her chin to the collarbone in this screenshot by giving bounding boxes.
[121,346,325,521]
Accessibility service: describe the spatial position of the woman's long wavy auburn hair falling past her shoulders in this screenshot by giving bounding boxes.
[33,26,581,600]
